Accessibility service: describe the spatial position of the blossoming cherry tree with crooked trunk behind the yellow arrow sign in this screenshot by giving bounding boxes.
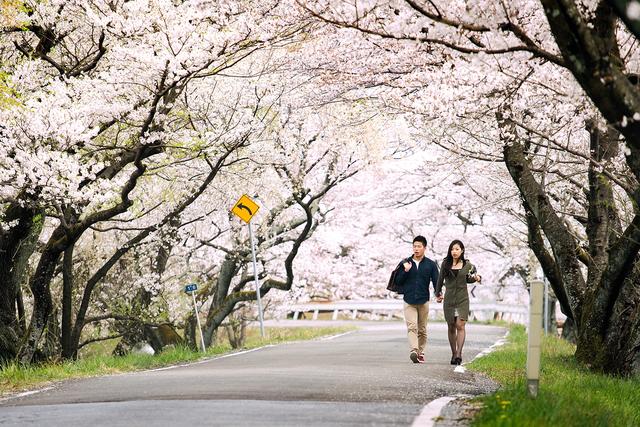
[170,97,375,345]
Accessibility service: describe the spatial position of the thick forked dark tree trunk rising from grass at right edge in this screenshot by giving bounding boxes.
[505,130,640,375]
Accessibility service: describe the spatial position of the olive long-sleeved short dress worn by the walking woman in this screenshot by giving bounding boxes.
[436,261,475,323]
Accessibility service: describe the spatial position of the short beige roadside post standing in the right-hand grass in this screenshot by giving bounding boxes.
[527,280,544,397]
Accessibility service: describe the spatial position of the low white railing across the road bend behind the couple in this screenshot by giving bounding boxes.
[288,299,529,323]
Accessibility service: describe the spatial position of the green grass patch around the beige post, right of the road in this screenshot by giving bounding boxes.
[469,326,640,427]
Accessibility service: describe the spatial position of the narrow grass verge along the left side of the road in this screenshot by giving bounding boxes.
[0,327,353,395]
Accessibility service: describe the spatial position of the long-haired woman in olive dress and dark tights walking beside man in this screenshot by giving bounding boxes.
[436,240,482,365]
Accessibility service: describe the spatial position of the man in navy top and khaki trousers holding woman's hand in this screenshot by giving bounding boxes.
[395,236,438,363]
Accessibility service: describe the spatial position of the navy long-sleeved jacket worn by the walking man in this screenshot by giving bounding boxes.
[395,257,438,304]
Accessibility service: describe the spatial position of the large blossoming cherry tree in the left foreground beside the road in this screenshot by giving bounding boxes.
[2,1,308,362]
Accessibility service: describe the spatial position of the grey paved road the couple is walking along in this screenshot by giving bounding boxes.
[0,322,505,427]
